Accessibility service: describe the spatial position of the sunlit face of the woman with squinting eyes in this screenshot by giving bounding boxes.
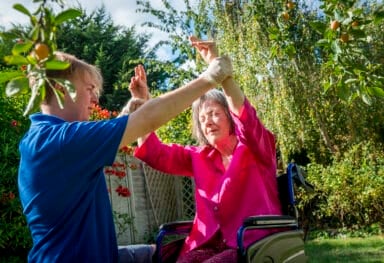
[199,100,231,146]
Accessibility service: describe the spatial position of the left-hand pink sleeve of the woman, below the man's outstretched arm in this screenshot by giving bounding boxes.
[134,133,192,176]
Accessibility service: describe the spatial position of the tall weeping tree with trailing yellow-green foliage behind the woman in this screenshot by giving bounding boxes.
[138,0,384,164]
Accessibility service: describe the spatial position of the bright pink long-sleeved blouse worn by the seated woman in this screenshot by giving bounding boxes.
[135,99,281,253]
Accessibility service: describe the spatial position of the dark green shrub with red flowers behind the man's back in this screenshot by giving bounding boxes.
[0,93,32,254]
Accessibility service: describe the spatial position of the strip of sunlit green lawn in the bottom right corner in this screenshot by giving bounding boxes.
[305,235,384,263]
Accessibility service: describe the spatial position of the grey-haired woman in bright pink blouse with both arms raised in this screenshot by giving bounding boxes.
[131,37,281,262]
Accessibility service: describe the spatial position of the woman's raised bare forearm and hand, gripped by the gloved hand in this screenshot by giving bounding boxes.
[189,36,245,115]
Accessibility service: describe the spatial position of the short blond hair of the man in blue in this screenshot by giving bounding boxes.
[39,51,103,103]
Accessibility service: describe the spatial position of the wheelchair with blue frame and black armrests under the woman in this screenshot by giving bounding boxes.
[154,163,314,263]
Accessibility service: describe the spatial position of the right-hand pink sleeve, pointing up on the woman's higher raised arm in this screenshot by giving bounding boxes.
[231,98,276,163]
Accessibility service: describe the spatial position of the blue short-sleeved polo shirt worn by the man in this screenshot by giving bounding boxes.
[18,113,128,263]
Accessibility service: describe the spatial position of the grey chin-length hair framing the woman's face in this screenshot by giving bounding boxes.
[192,89,235,145]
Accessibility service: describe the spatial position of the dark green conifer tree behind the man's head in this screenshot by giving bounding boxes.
[57,6,152,110]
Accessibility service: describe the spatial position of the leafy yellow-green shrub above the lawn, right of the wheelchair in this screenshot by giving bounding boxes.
[300,142,384,234]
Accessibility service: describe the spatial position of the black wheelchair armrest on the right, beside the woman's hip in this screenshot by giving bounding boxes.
[243,215,298,228]
